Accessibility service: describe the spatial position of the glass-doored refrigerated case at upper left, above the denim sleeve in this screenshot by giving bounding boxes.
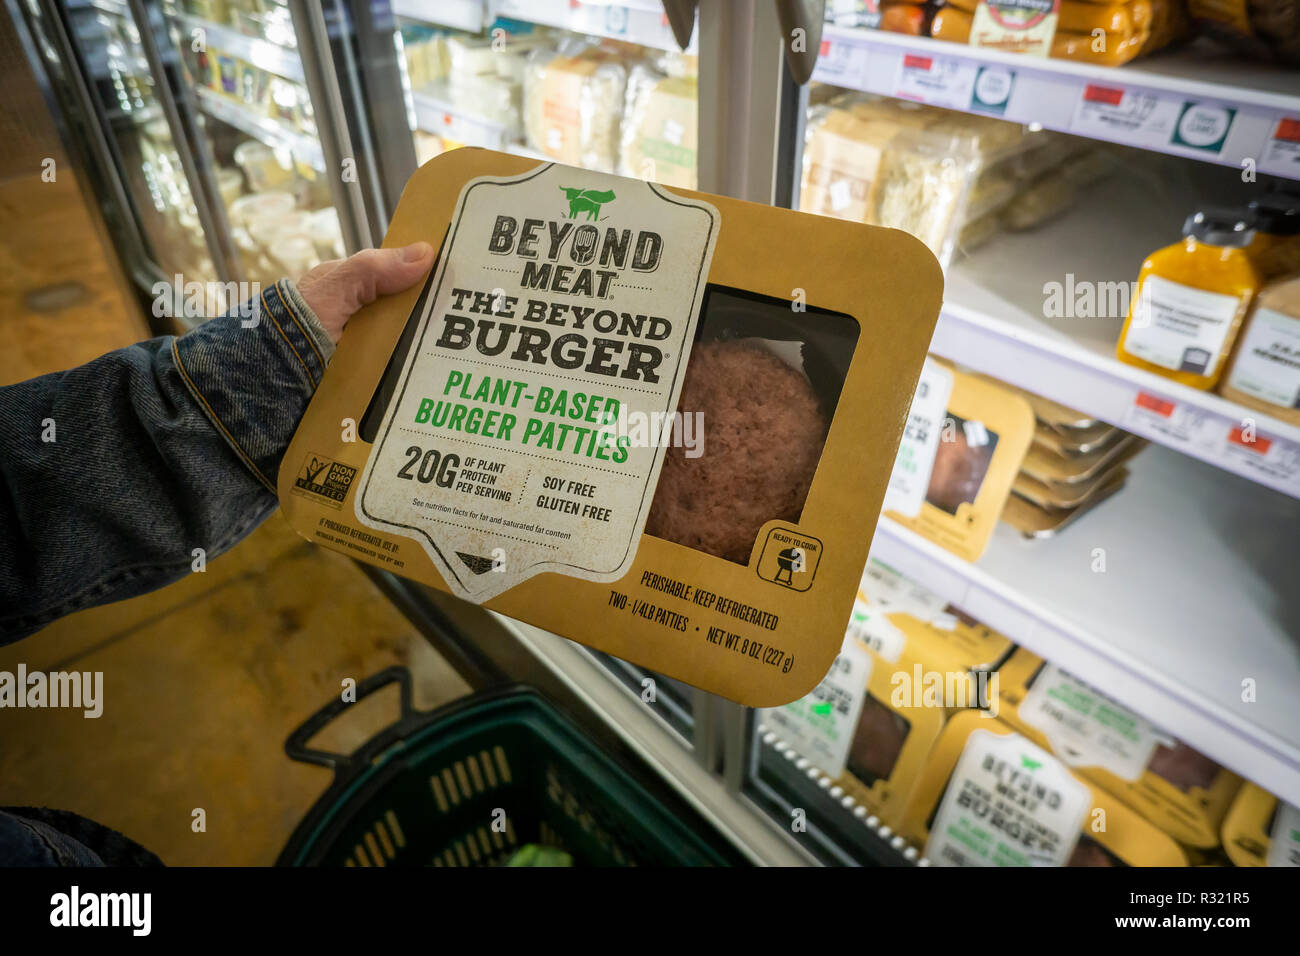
[13,0,371,323]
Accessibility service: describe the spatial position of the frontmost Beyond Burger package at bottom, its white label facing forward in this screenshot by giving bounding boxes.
[902,710,1187,866]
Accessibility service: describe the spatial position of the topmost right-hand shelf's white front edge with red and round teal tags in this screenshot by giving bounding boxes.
[813,25,1300,179]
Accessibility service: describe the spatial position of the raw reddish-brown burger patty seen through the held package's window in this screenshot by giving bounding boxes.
[646,342,827,564]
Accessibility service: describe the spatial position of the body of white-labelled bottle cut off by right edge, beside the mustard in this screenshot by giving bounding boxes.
[1219,274,1300,425]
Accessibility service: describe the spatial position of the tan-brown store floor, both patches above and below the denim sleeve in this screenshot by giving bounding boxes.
[0,46,468,865]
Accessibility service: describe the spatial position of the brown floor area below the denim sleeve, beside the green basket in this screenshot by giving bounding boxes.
[0,512,469,865]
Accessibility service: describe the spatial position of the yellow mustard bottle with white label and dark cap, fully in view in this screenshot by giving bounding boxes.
[1115,209,1260,389]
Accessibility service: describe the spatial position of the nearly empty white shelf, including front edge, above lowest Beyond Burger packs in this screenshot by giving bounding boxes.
[872,447,1300,803]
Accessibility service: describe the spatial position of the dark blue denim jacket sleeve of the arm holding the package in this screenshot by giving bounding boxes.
[0,281,334,644]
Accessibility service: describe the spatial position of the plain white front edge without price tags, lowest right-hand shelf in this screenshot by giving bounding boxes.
[871,518,1300,803]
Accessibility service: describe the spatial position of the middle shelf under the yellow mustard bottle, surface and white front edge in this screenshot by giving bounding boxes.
[931,166,1300,497]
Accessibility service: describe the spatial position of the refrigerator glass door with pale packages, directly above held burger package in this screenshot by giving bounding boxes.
[391,0,698,189]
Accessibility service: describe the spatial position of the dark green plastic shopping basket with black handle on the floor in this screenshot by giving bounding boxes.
[277,667,740,866]
